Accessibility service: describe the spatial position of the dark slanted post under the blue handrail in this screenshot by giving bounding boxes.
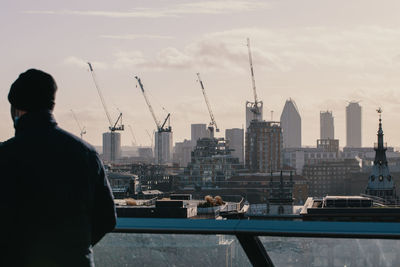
[236,234,274,267]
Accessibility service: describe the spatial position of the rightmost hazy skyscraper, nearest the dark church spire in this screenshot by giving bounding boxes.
[346,101,362,147]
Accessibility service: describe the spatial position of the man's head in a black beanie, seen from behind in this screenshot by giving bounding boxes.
[8,69,57,123]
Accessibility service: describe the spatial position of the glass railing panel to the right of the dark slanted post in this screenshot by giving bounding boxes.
[260,236,400,267]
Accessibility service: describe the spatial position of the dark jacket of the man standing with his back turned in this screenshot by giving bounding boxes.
[0,111,116,266]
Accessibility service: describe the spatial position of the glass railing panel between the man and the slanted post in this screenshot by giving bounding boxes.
[94,233,251,267]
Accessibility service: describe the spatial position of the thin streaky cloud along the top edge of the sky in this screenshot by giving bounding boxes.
[23,0,270,18]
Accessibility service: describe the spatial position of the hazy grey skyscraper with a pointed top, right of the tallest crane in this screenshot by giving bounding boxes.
[281,99,301,148]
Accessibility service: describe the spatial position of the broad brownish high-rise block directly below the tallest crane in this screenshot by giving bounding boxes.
[245,121,283,172]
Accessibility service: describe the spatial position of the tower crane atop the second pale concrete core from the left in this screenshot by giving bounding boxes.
[135,76,172,164]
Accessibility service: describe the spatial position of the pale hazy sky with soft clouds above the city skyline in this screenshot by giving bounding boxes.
[0,0,400,147]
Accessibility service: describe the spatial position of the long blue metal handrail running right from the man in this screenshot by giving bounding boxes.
[114,218,400,239]
